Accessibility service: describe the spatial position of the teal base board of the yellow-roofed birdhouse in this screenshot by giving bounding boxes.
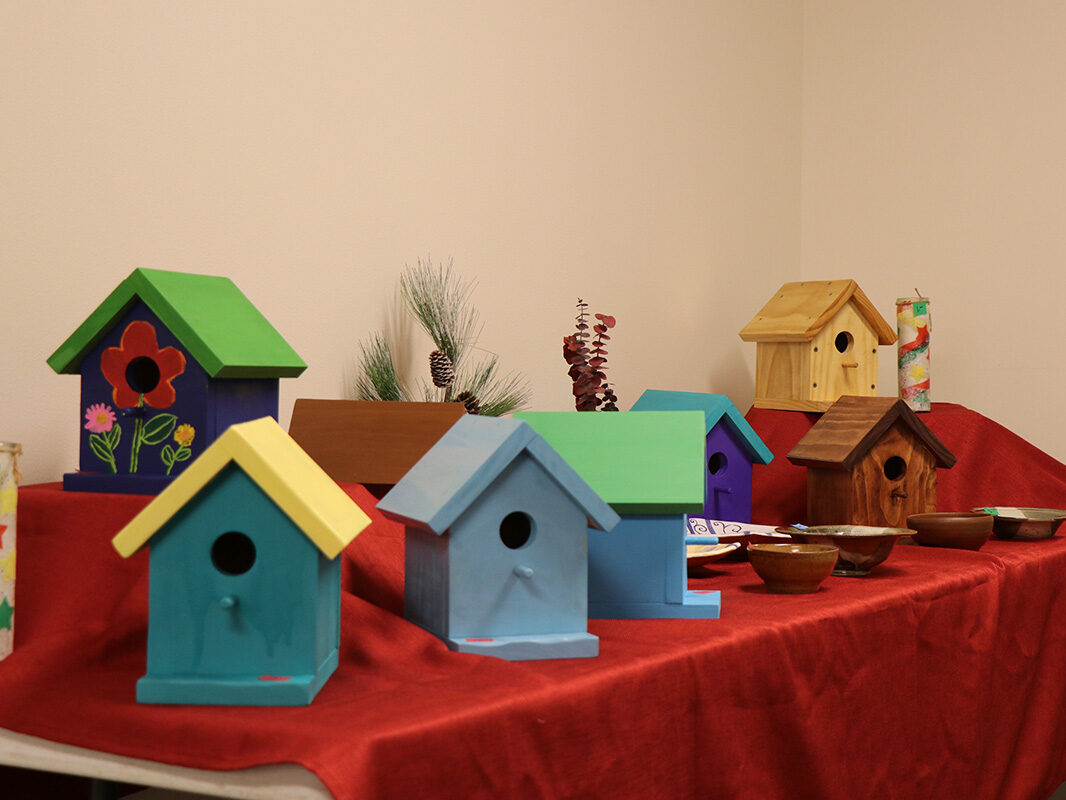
[136,650,337,706]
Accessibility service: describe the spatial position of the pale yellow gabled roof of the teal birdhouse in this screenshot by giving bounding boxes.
[111,417,370,558]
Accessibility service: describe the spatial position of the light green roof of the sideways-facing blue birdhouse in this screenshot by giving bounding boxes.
[515,411,706,514]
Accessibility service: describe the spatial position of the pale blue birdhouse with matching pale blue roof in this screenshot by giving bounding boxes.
[377,415,618,661]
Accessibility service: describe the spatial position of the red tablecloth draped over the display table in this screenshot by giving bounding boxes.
[0,406,1066,800]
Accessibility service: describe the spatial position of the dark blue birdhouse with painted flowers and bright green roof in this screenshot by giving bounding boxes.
[48,269,307,494]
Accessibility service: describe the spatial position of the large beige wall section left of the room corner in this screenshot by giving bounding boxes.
[0,0,803,481]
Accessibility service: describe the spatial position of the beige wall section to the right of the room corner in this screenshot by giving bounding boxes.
[802,0,1066,462]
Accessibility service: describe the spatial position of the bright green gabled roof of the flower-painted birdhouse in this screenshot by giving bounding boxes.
[48,270,307,378]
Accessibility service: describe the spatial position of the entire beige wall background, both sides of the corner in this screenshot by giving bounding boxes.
[8,0,1066,488]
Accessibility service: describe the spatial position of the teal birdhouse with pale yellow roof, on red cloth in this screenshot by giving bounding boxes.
[113,417,370,705]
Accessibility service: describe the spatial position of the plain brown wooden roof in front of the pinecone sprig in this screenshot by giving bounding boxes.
[289,398,466,484]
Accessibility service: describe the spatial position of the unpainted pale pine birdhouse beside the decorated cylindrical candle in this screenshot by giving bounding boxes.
[740,281,895,411]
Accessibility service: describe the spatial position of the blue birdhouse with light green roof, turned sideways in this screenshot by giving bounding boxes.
[515,411,722,619]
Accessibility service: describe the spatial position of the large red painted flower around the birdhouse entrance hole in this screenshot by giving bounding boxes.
[100,320,185,409]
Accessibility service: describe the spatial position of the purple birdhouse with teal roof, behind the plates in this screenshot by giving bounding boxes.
[631,389,774,523]
